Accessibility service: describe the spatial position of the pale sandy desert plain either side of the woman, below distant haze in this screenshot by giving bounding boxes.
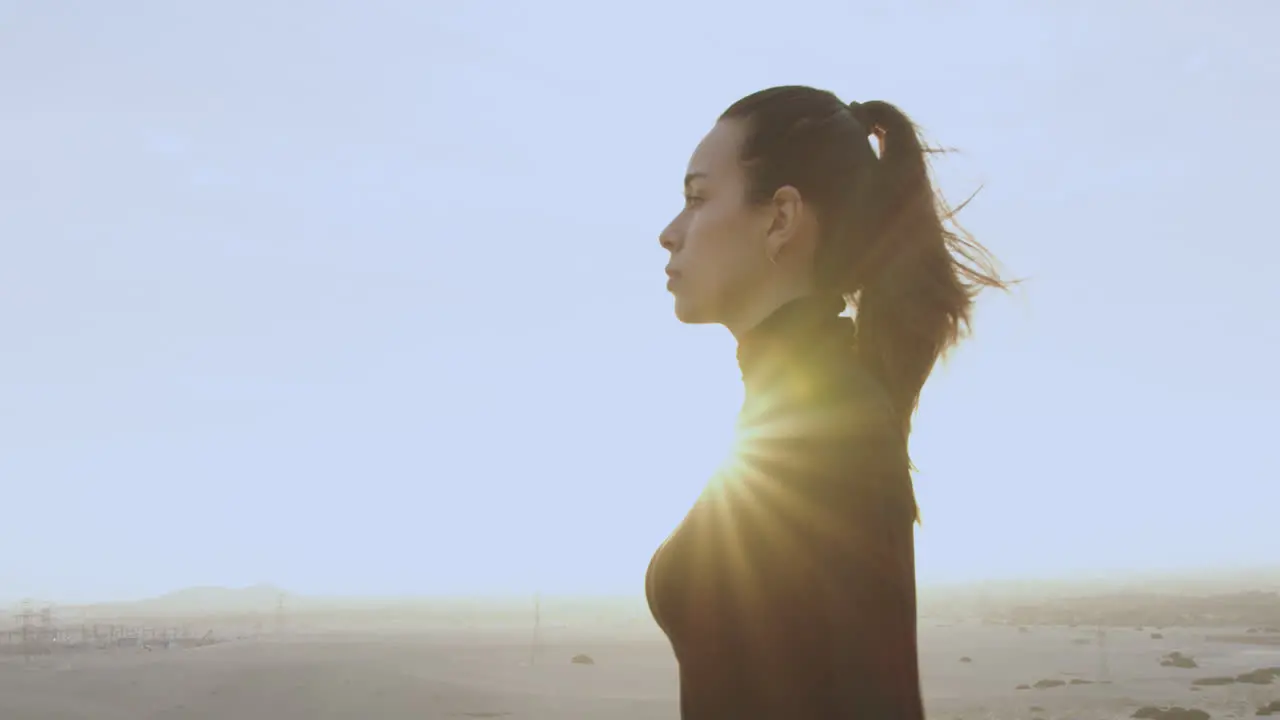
[0,621,1280,720]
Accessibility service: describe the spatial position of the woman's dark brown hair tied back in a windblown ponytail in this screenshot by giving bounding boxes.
[721,86,1009,433]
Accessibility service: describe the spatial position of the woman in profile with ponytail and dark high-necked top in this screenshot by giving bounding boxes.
[646,87,1004,720]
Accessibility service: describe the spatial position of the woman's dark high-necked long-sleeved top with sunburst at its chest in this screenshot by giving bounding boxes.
[645,297,924,720]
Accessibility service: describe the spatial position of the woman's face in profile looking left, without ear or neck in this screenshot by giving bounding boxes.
[659,120,771,324]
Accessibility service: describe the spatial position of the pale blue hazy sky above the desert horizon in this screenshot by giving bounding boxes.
[0,0,1280,601]
